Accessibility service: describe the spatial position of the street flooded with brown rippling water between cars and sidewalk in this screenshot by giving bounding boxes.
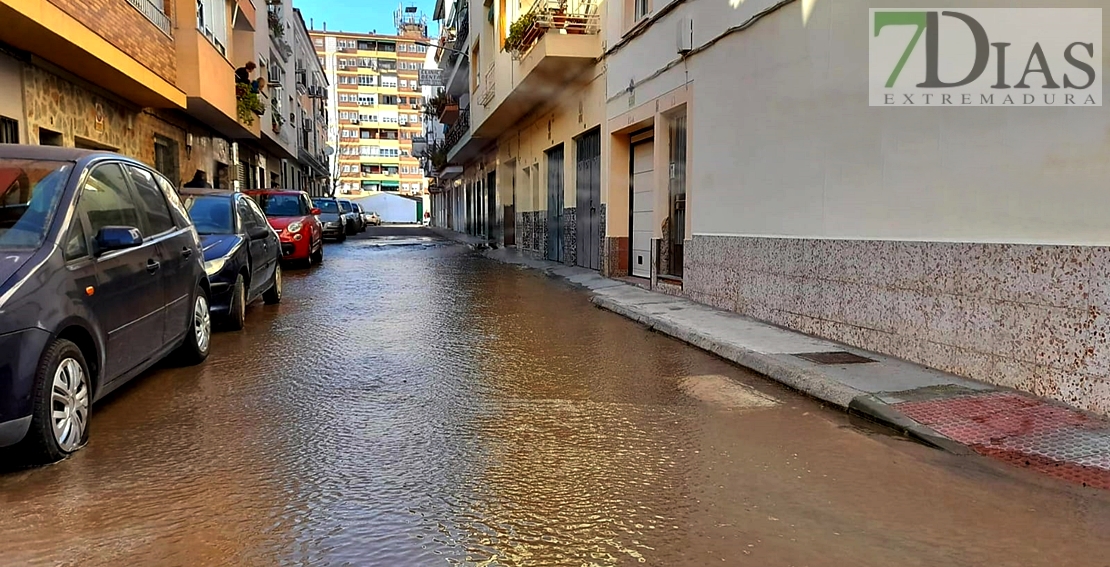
[0,229,1110,567]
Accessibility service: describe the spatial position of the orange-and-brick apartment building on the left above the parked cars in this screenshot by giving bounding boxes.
[0,0,328,193]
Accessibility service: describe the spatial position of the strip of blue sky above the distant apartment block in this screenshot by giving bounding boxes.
[293,0,438,36]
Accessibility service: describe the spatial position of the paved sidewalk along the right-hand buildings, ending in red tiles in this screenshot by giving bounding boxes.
[436,230,1110,489]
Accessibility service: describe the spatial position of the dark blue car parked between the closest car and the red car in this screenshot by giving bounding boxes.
[181,189,281,331]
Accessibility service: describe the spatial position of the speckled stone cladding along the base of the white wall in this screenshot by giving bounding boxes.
[684,235,1110,414]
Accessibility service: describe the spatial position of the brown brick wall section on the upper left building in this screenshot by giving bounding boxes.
[50,0,178,83]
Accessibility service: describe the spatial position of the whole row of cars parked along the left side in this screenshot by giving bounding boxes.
[0,144,381,463]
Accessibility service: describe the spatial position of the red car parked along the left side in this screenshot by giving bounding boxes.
[243,189,324,266]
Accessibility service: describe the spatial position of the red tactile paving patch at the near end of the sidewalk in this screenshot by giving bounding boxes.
[895,392,1110,489]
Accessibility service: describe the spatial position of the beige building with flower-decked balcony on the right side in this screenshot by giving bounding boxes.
[432,0,607,269]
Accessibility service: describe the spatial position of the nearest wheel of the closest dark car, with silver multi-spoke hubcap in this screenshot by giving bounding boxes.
[23,338,92,464]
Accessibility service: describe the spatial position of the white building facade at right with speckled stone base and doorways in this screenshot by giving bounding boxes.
[605,0,1110,414]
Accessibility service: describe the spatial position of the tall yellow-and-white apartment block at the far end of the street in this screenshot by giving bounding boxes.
[310,11,428,195]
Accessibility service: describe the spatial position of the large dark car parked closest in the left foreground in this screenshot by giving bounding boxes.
[0,145,211,463]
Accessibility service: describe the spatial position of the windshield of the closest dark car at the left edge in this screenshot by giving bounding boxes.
[0,158,73,249]
